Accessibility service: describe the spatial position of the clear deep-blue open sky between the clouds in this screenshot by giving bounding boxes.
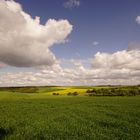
[17,0,140,59]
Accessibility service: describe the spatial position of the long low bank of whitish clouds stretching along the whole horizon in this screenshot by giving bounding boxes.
[0,50,140,86]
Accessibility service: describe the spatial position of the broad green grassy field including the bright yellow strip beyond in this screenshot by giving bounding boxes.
[0,87,140,140]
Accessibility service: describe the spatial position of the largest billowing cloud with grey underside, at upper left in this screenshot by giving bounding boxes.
[0,0,72,67]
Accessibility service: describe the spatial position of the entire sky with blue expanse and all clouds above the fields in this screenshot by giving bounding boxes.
[0,0,140,86]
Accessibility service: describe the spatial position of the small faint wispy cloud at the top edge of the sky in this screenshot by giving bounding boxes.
[64,0,80,8]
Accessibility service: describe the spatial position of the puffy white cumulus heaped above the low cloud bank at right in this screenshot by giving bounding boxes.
[92,50,140,70]
